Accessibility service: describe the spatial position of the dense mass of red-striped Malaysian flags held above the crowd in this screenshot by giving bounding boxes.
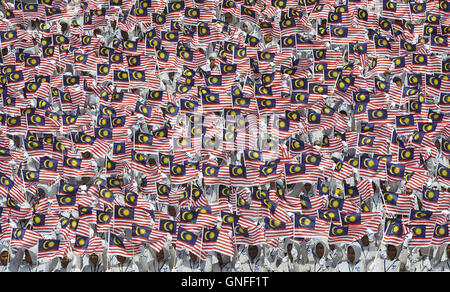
[0,0,450,259]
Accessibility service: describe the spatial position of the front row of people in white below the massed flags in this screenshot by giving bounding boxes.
[0,235,450,272]
